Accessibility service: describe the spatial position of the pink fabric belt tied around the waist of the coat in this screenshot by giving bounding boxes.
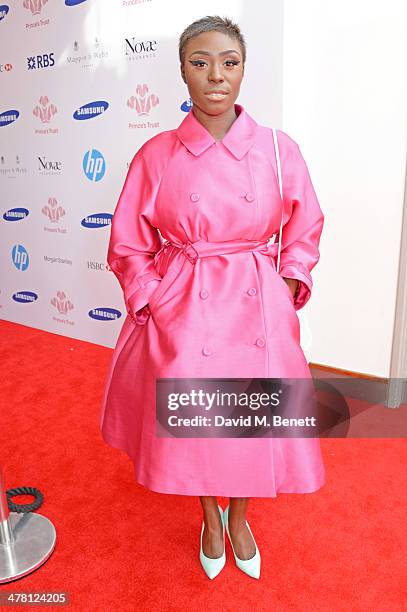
[158,234,278,264]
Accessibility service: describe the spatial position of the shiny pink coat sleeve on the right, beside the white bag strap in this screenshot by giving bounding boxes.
[279,133,324,310]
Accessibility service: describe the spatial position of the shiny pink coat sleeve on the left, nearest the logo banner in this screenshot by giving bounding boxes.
[107,147,162,320]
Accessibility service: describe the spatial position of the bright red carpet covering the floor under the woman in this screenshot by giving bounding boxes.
[0,322,407,612]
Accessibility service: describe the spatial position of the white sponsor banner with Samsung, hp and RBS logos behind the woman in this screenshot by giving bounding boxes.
[0,0,282,347]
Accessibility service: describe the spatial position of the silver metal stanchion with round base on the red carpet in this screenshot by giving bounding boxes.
[0,465,56,583]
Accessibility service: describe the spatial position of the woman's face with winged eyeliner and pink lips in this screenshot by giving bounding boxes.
[181,31,244,115]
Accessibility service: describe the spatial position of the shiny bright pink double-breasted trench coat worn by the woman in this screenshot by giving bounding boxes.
[100,104,325,497]
